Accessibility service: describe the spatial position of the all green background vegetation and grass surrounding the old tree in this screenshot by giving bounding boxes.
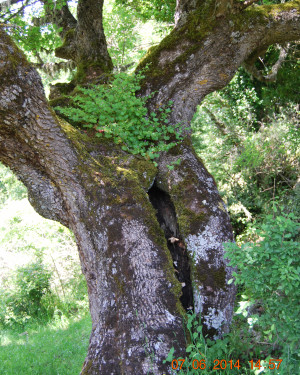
[0,0,300,375]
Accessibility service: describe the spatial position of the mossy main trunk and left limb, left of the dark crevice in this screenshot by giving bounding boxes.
[0,29,184,374]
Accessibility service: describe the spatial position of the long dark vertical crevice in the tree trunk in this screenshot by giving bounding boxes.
[148,183,194,311]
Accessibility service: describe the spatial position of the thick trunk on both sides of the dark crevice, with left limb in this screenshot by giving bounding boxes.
[0,28,234,375]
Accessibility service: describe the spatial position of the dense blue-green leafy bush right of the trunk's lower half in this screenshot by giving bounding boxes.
[226,213,300,374]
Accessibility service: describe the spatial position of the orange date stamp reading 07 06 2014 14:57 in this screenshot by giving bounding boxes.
[171,358,282,371]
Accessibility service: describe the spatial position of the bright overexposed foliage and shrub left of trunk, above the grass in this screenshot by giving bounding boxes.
[0,165,88,329]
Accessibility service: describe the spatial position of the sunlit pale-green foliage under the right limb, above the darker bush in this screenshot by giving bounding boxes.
[193,70,300,235]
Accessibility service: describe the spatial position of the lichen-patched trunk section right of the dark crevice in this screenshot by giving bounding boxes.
[156,145,235,338]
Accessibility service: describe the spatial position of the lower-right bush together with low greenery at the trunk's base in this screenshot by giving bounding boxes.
[166,214,300,375]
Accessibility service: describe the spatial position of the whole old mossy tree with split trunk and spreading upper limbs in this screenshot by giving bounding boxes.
[0,0,300,374]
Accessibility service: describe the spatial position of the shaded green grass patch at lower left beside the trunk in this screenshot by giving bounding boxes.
[0,316,91,375]
